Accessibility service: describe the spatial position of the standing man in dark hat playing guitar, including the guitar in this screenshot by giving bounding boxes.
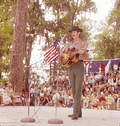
[60,26,88,120]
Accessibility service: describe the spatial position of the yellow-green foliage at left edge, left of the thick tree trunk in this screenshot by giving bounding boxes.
[0,1,13,81]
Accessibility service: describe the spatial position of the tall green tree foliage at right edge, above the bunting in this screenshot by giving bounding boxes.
[94,1,120,59]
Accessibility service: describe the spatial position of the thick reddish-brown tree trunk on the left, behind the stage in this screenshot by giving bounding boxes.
[9,0,28,92]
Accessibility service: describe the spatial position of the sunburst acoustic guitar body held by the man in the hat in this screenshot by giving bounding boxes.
[61,48,79,68]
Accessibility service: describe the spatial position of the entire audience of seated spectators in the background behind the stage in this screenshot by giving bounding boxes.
[0,72,120,110]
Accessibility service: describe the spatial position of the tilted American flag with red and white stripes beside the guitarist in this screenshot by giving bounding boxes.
[44,37,61,64]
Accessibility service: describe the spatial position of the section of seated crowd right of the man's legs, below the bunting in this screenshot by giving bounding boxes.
[82,72,120,109]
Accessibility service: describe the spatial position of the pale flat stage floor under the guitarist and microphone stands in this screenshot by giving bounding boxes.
[0,106,120,126]
